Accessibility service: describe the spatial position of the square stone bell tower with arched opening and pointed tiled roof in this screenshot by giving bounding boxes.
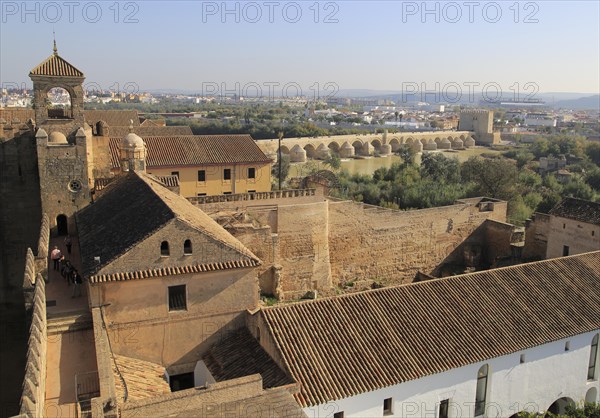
[29,42,93,235]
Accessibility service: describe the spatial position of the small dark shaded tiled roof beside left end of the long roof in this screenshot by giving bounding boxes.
[203,328,294,389]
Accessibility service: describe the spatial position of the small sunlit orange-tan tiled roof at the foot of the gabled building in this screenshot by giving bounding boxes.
[113,354,171,403]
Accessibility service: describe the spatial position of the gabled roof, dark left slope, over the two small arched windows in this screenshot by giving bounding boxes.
[76,172,260,278]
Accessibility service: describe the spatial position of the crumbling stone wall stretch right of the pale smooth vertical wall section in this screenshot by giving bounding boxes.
[329,198,507,285]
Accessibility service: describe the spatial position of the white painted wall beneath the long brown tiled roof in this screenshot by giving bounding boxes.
[304,331,600,418]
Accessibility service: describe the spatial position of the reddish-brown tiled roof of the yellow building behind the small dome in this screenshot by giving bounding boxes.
[110,134,271,169]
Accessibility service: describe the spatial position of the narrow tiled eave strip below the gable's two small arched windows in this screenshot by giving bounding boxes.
[90,259,259,283]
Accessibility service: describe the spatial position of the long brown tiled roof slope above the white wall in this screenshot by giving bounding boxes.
[260,251,600,406]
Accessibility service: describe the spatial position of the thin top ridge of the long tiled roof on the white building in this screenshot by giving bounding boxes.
[259,250,600,311]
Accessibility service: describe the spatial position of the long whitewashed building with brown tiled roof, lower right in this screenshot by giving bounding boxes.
[248,251,600,418]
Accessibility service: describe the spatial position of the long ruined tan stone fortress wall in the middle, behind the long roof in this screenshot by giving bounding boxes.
[198,196,512,299]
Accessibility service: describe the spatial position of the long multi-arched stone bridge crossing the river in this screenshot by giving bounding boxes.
[256,131,475,162]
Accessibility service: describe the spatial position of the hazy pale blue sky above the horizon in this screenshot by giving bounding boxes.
[0,0,600,94]
